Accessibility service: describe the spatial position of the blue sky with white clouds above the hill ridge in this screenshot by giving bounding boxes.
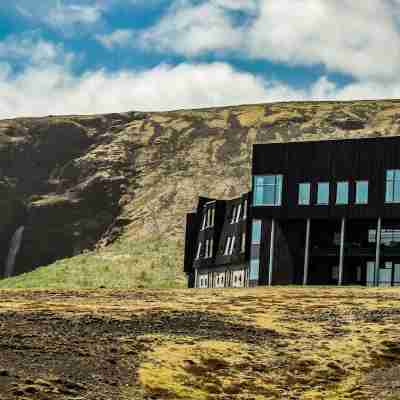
[0,0,400,118]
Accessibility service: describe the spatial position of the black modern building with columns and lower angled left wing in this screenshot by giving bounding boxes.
[185,137,400,287]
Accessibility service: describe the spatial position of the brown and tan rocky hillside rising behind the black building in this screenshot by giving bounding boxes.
[0,101,400,273]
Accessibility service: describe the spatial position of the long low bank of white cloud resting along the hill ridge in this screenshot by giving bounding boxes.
[0,33,400,118]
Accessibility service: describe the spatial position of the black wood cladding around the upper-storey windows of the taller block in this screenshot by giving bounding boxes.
[252,137,400,219]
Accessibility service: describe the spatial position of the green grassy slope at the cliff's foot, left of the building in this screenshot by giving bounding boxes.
[0,238,186,289]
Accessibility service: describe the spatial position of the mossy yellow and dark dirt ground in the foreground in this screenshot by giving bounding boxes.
[0,288,400,400]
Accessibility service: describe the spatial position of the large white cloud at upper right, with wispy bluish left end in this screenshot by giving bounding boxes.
[140,0,400,80]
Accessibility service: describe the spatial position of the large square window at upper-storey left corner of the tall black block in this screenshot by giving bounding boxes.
[254,175,283,206]
